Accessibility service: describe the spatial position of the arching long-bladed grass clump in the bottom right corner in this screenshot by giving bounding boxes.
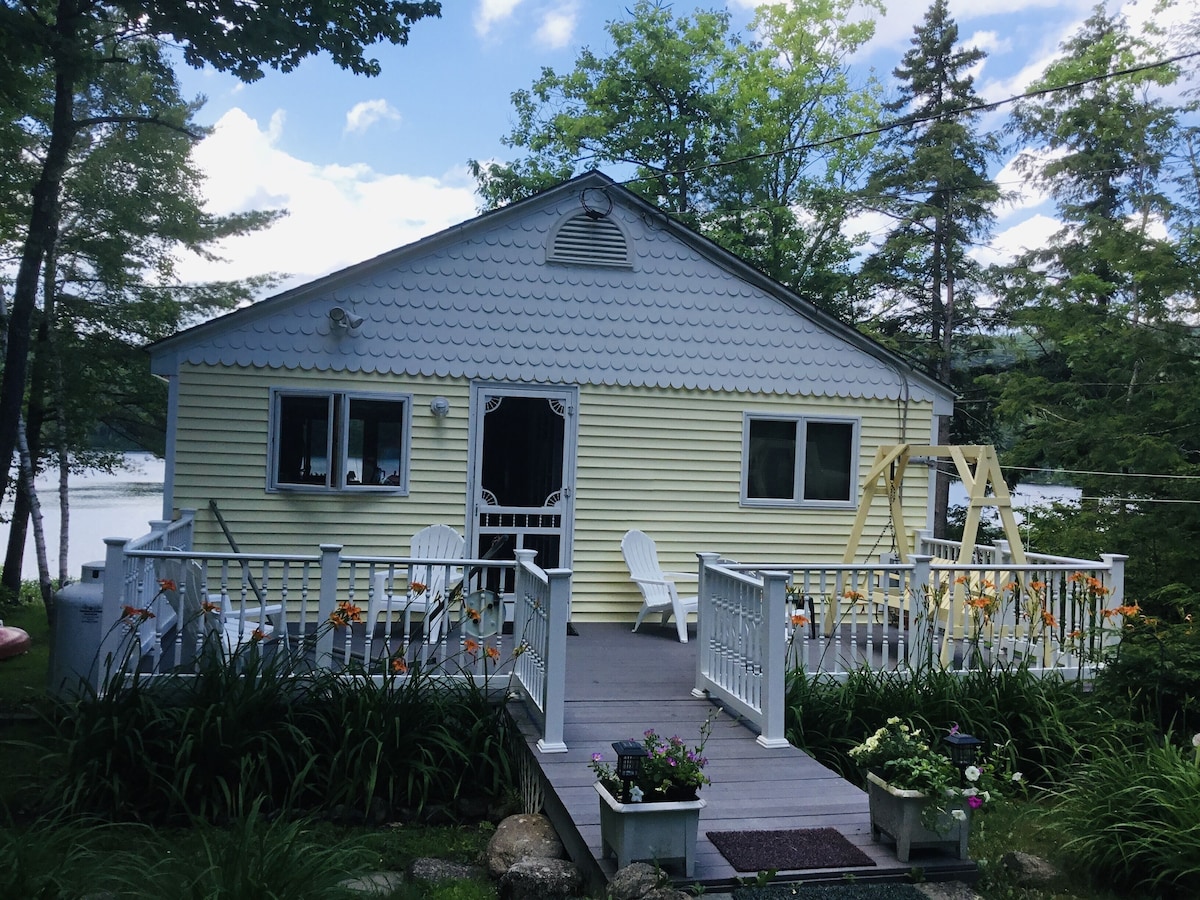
[1054,734,1200,898]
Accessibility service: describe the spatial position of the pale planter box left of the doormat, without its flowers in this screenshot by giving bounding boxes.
[594,781,708,876]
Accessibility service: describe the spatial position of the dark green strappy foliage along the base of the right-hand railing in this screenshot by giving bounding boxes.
[787,667,1132,780]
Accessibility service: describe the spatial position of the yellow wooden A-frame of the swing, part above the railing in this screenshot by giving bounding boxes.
[842,444,1026,565]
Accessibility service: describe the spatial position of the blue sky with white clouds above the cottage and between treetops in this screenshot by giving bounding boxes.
[171,0,1190,300]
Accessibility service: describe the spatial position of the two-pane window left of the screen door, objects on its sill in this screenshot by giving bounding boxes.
[268,388,413,493]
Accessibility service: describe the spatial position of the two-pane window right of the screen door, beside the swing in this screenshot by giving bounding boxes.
[742,413,858,508]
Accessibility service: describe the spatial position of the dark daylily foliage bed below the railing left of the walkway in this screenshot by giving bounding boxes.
[47,643,514,822]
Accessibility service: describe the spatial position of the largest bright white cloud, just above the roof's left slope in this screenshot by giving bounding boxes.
[179,108,478,287]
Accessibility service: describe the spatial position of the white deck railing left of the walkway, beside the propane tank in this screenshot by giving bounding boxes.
[92,510,571,752]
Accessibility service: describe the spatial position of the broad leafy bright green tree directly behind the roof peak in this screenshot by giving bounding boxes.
[472,0,878,313]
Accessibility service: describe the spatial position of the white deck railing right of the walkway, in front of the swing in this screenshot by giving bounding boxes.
[696,541,1129,746]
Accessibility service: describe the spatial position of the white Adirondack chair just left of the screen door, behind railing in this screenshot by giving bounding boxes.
[367,524,467,647]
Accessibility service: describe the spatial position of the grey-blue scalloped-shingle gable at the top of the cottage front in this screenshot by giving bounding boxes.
[151,173,950,412]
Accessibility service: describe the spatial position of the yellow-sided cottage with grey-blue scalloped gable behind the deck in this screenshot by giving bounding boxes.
[151,173,953,620]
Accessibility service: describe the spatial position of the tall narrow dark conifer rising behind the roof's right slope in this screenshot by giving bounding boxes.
[858,0,1001,382]
